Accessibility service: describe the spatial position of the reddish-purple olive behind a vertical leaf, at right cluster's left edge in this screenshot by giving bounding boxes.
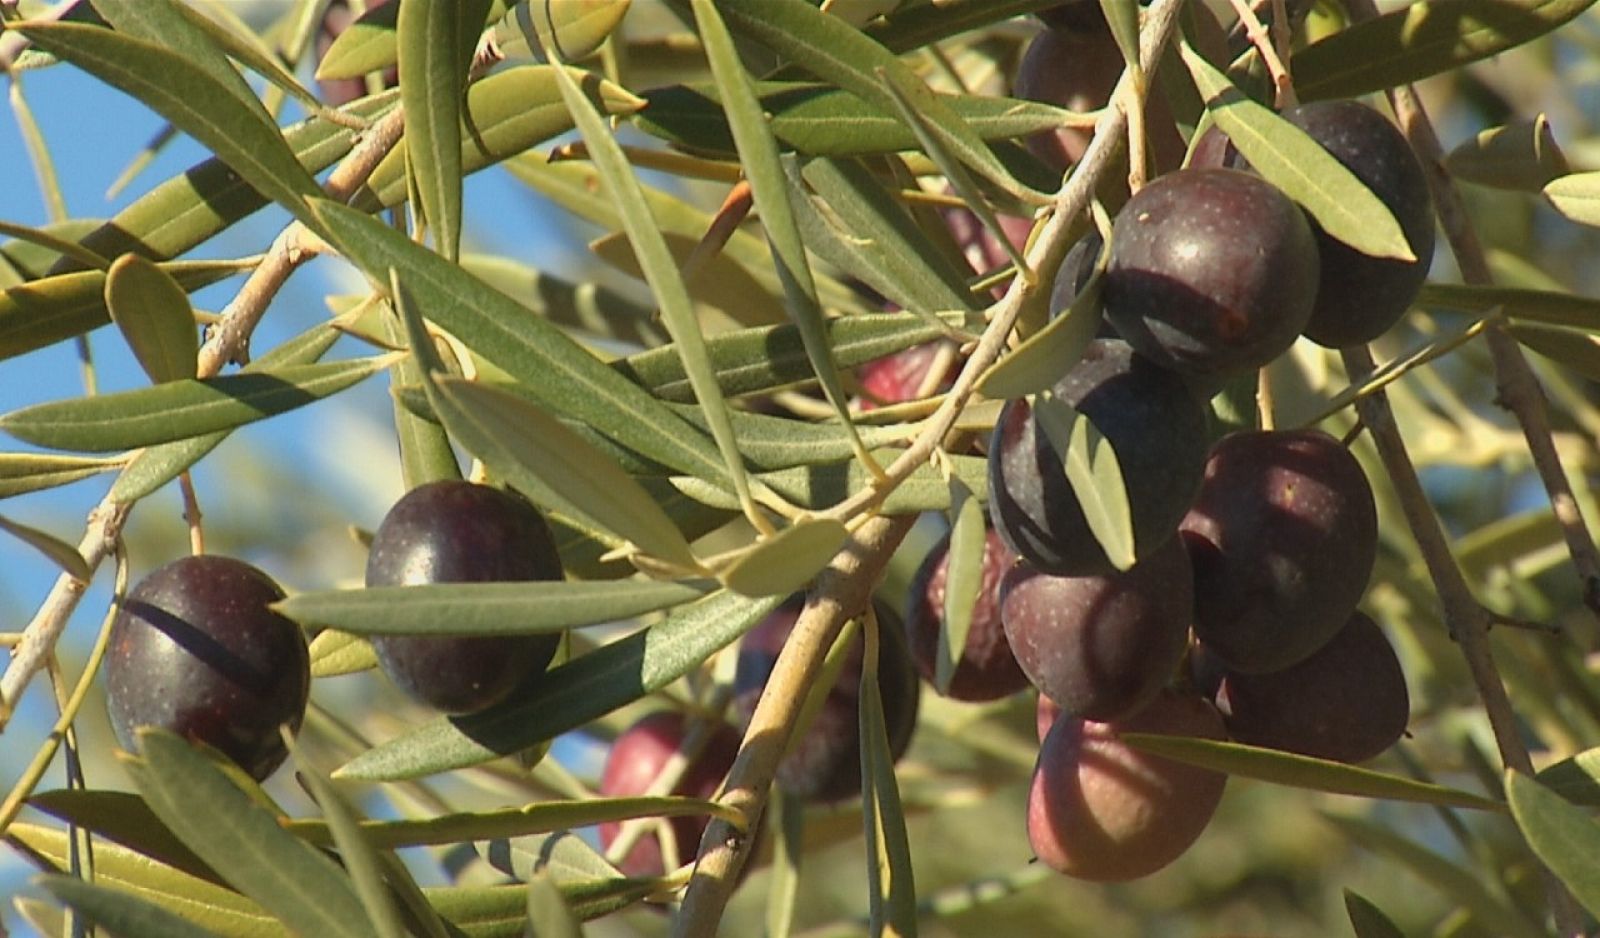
[906,528,1027,701]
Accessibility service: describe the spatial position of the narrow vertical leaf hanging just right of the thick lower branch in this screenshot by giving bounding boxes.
[858,623,918,938]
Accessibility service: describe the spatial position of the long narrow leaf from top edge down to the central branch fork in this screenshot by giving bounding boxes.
[694,0,866,455]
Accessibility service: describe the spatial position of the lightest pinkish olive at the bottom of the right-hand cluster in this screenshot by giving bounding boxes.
[1027,691,1227,882]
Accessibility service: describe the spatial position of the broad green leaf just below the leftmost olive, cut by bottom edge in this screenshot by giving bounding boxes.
[125,727,366,938]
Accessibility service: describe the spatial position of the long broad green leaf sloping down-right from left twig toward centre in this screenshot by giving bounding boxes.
[305,202,726,482]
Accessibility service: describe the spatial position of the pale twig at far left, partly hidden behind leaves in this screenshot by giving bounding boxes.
[0,100,405,732]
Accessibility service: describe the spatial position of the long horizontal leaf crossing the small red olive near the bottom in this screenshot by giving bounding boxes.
[283,796,739,850]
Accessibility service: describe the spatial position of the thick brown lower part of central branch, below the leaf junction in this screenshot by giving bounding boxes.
[672,515,915,938]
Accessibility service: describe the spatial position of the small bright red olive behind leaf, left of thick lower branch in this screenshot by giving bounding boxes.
[600,711,739,877]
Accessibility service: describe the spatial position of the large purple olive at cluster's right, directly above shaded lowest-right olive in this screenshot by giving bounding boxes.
[1181,431,1378,674]
